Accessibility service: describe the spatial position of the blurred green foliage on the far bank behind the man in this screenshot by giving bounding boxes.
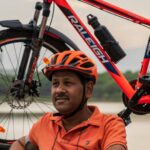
[0,71,137,101]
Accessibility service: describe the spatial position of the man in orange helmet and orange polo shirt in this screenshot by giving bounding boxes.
[11,51,127,150]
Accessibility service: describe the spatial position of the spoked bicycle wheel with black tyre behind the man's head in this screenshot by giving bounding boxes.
[0,29,77,140]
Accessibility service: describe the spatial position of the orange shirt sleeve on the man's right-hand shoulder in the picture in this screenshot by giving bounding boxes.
[101,115,127,150]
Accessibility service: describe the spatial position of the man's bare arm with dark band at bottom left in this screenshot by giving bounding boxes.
[10,137,38,150]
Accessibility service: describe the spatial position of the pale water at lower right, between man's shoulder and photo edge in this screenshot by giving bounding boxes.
[126,116,150,150]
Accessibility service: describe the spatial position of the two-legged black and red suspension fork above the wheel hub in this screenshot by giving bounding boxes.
[18,3,50,84]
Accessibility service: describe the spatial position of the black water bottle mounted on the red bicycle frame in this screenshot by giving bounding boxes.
[87,14,126,63]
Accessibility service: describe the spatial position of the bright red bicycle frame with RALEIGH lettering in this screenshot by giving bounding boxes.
[48,0,150,104]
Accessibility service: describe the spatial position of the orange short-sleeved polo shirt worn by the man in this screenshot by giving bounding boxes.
[29,106,127,150]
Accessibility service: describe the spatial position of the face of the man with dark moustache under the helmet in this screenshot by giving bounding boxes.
[51,71,83,114]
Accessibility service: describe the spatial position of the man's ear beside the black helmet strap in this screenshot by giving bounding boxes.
[85,81,94,99]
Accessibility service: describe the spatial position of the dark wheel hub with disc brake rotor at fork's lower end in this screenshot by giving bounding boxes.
[7,80,39,109]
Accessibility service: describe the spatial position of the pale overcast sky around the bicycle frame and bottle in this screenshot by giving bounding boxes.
[0,0,150,72]
